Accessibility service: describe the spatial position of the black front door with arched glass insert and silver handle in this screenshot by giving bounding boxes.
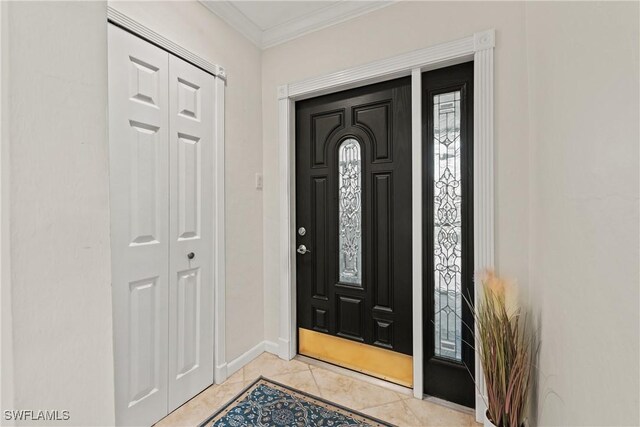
[295,77,412,385]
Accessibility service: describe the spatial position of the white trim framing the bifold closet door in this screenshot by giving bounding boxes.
[107,6,227,384]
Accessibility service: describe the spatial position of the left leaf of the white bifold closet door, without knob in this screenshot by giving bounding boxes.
[108,25,169,425]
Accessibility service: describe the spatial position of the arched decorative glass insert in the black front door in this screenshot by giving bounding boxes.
[338,138,362,285]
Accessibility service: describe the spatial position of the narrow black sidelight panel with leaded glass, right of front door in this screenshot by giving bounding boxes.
[422,62,475,407]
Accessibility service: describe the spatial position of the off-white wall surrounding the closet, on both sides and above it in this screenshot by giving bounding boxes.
[2,2,263,426]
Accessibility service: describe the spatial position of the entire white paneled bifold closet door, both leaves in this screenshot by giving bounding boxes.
[108,25,215,425]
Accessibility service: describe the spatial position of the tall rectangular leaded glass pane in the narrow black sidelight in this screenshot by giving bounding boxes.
[433,91,463,362]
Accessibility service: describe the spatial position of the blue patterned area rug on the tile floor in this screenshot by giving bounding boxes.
[200,377,393,427]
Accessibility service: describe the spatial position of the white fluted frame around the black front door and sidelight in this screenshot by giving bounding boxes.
[278,29,495,421]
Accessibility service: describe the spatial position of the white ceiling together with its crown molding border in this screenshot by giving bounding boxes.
[200,0,396,49]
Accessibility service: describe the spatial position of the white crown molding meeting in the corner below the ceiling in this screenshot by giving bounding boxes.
[199,0,398,49]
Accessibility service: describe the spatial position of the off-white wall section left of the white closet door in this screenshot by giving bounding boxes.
[3,2,114,425]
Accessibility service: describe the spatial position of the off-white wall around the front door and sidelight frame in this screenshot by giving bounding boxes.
[262,2,529,360]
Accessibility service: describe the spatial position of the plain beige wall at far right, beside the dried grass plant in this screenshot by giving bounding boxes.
[524,2,640,426]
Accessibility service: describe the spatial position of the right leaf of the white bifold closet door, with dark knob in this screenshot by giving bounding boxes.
[169,56,215,411]
